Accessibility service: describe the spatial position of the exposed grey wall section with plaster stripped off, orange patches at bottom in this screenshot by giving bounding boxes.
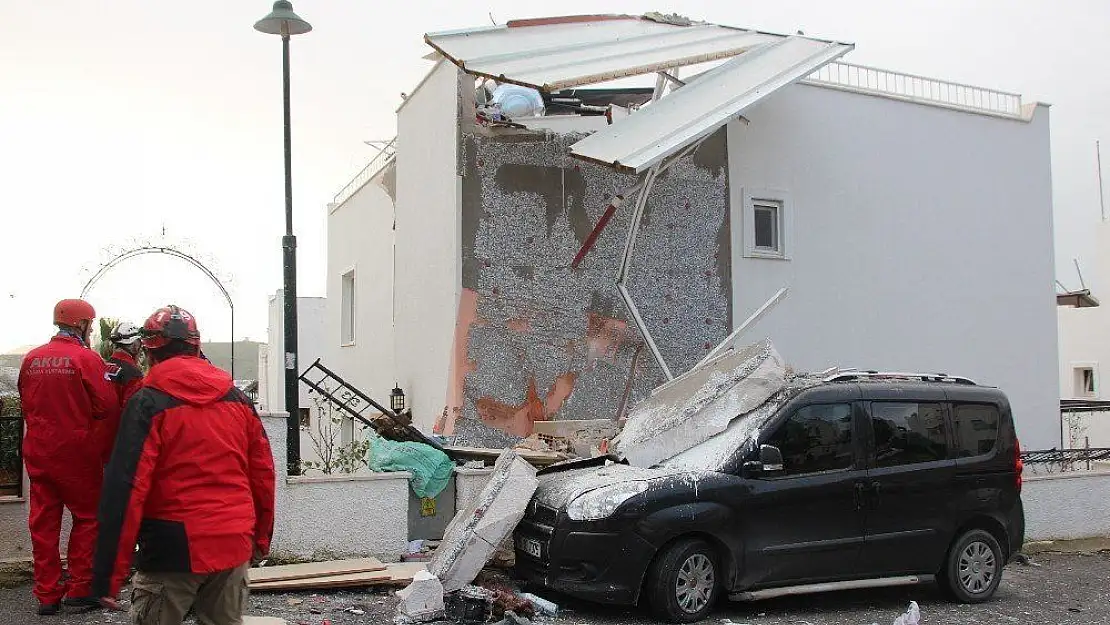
[436,130,731,446]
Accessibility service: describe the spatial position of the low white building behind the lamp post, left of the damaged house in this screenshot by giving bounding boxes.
[258,289,329,460]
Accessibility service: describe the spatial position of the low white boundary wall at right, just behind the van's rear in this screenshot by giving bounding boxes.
[1021,472,1110,541]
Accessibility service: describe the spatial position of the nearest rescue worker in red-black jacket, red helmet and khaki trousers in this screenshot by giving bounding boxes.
[92,305,274,625]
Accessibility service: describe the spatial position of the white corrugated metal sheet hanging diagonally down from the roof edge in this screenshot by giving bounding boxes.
[571,37,852,172]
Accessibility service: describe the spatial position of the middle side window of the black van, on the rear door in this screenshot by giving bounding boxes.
[871,402,948,466]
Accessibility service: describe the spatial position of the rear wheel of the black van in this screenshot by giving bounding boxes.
[941,530,1005,603]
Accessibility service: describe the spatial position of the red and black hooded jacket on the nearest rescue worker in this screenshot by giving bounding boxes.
[92,356,274,596]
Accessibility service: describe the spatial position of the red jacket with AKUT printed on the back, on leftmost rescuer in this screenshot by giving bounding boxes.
[19,334,120,478]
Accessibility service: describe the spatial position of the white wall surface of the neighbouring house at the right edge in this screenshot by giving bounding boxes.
[1057,221,1110,447]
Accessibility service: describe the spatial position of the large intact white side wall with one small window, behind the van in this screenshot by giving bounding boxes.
[728,84,1059,448]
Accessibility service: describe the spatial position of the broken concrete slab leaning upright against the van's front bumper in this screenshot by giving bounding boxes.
[428,450,538,593]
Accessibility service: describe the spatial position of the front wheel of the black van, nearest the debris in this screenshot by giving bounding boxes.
[645,538,720,623]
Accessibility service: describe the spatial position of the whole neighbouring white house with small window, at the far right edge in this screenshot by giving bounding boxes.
[1057,221,1110,447]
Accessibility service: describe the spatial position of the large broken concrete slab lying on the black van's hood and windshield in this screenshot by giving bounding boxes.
[614,341,786,467]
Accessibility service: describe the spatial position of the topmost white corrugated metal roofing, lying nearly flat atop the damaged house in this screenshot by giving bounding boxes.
[424,16,784,91]
